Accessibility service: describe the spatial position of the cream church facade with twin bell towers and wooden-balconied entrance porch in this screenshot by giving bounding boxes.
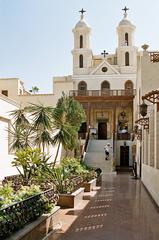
[62,9,138,167]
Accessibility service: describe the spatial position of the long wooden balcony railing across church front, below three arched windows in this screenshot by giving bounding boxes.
[69,89,136,97]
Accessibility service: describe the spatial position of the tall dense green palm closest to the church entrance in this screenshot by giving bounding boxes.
[53,93,85,166]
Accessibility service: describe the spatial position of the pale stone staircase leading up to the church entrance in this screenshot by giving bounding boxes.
[84,139,113,173]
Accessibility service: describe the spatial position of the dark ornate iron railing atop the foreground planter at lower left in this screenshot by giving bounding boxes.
[0,189,58,239]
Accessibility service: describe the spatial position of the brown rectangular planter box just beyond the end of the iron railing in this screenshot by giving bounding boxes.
[57,187,84,208]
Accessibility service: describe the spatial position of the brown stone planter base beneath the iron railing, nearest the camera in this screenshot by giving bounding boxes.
[7,206,60,240]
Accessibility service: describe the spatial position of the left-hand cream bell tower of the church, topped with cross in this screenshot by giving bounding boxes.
[72,8,92,75]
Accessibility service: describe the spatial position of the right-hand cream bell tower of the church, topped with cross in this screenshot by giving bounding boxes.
[117,7,137,73]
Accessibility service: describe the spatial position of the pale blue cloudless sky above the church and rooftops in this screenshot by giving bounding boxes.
[0,0,159,93]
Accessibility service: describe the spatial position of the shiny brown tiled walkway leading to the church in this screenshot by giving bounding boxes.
[49,174,159,240]
